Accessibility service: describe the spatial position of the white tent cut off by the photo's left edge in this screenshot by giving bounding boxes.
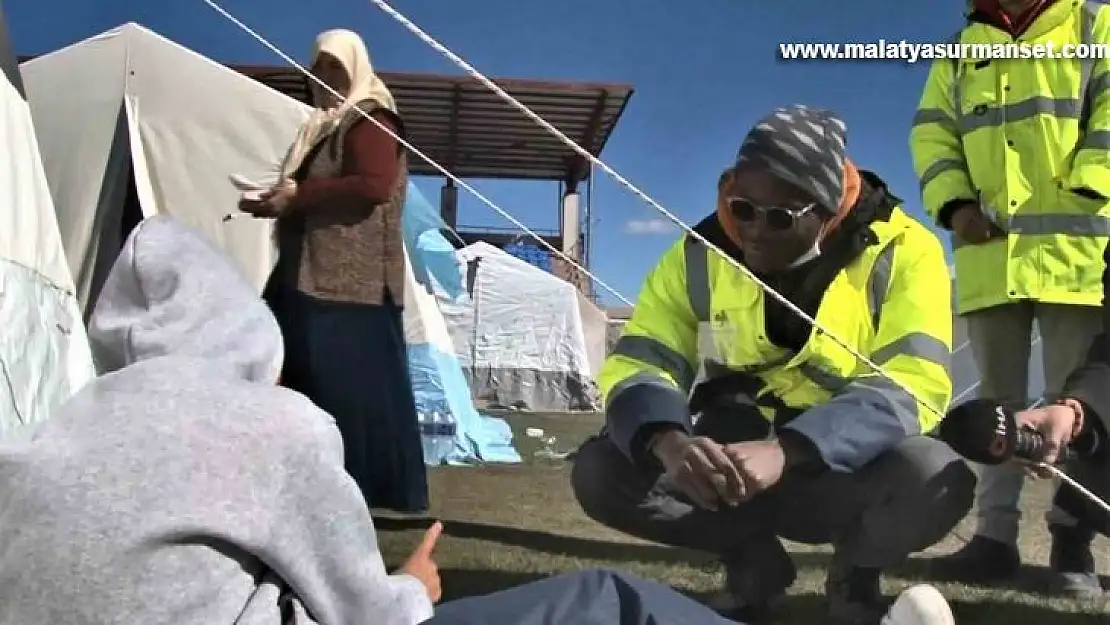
[0,1,93,438]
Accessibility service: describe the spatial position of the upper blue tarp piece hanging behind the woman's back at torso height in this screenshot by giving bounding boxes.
[401,181,465,299]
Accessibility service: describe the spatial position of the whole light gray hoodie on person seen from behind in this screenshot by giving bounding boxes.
[0,218,432,625]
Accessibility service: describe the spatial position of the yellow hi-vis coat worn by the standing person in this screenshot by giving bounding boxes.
[910,0,1110,313]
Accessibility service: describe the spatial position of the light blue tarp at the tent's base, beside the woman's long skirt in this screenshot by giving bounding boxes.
[408,343,521,465]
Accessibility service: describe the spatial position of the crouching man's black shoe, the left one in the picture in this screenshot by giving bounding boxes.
[709,536,798,624]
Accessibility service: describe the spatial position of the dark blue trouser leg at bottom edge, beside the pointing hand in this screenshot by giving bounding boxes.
[425,571,737,625]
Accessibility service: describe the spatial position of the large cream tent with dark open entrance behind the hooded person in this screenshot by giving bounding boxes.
[22,23,309,312]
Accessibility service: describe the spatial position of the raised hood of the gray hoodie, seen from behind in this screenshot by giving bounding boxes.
[89,215,283,383]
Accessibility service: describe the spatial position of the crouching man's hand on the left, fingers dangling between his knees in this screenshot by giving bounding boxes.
[652,432,746,511]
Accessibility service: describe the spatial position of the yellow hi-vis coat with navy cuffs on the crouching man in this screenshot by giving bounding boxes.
[598,208,952,471]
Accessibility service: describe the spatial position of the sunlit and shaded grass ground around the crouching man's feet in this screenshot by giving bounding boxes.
[375,414,1110,625]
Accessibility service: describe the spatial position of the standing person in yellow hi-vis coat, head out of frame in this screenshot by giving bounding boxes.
[910,0,1110,595]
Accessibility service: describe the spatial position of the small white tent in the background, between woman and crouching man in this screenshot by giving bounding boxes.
[440,243,606,411]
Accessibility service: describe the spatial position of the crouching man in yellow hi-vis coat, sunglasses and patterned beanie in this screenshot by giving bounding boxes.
[572,105,975,625]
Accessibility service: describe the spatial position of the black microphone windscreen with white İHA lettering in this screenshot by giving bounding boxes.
[937,399,1018,464]
